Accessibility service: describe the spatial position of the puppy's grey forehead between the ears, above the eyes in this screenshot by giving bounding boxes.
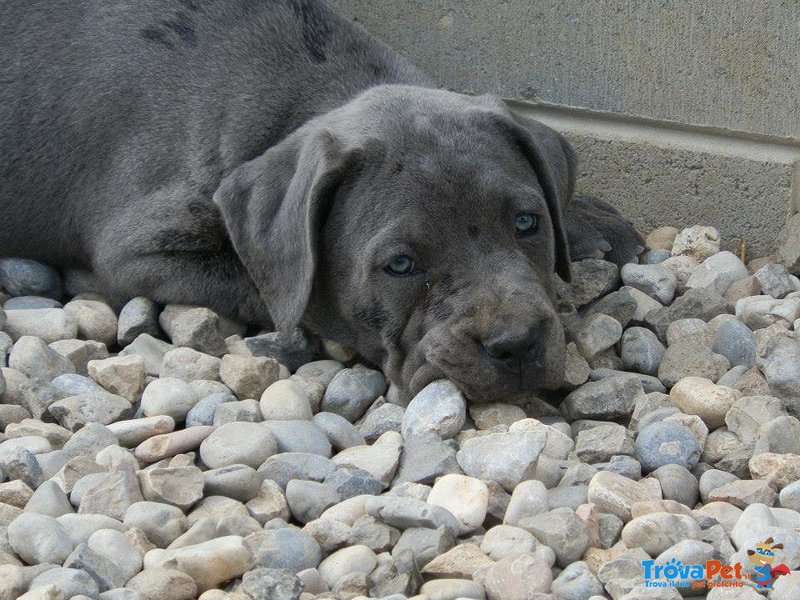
[337,86,542,212]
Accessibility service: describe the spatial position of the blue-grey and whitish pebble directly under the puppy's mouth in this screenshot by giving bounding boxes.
[320,366,386,423]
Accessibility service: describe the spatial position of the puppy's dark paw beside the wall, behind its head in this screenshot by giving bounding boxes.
[565,196,646,266]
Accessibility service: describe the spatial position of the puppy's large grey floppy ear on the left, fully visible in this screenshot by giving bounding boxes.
[214,128,355,330]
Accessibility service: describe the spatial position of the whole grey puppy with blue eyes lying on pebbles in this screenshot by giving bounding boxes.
[0,0,638,401]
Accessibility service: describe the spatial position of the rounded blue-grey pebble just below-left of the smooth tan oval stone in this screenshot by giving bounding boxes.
[635,423,702,473]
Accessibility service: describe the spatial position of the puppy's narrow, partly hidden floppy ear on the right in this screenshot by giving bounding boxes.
[511,112,578,281]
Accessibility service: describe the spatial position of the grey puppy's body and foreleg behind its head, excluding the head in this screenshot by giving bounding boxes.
[0,0,426,322]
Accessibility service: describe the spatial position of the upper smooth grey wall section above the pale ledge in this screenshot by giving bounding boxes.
[337,0,800,139]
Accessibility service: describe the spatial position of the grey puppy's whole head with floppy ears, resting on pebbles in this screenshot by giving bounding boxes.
[215,86,574,401]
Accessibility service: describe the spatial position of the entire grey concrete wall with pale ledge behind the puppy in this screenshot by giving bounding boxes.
[335,0,800,253]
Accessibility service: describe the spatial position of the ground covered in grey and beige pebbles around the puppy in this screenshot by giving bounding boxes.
[0,227,800,600]
